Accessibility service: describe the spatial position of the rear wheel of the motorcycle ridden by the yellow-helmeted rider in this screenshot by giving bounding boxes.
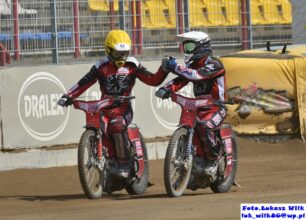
[126,132,149,195]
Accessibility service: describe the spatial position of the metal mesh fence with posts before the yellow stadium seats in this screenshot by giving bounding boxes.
[0,0,292,65]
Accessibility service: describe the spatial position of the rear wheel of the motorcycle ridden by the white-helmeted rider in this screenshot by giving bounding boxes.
[210,135,238,193]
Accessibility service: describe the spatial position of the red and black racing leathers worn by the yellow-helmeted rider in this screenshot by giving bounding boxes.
[68,56,168,163]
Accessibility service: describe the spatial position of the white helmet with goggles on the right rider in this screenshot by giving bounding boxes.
[177,31,212,64]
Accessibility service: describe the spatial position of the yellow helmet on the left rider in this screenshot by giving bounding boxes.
[104,30,131,67]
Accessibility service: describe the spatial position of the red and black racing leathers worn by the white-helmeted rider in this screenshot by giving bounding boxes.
[163,56,226,160]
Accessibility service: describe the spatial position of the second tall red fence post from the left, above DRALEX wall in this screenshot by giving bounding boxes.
[73,0,81,58]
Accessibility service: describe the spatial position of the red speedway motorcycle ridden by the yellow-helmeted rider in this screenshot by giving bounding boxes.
[58,96,149,199]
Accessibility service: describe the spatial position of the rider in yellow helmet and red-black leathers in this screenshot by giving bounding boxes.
[59,30,169,178]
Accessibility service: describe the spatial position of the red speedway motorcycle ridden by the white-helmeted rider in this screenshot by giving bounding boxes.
[155,91,238,197]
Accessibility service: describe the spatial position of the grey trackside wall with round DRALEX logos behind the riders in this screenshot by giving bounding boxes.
[0,61,182,170]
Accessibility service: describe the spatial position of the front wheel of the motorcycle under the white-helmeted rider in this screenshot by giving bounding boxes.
[164,127,192,197]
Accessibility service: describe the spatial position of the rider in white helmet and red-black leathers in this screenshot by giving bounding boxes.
[157,31,226,177]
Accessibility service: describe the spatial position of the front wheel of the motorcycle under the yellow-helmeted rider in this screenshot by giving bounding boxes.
[78,129,103,199]
